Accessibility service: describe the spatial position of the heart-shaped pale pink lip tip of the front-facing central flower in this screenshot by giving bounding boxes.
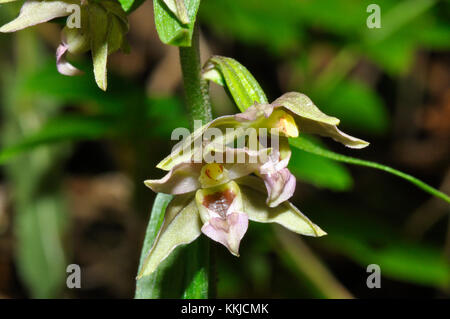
[202,212,248,257]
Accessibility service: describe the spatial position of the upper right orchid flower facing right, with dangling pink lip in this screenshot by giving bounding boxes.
[153,92,369,207]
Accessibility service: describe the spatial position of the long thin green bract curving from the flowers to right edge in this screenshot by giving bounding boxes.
[289,136,450,203]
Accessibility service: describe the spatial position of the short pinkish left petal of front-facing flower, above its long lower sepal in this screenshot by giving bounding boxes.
[144,163,202,195]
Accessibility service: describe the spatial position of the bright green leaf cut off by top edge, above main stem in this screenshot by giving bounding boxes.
[153,0,200,47]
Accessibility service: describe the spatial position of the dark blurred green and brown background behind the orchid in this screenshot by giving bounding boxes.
[0,0,450,298]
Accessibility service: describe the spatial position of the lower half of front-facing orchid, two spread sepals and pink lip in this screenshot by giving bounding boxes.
[138,176,326,278]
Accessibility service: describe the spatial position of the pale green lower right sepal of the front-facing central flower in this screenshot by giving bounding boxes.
[237,176,326,237]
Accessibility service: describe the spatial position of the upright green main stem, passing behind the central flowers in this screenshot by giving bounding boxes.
[180,28,215,298]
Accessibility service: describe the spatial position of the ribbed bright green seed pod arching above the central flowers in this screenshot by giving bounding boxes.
[203,56,268,112]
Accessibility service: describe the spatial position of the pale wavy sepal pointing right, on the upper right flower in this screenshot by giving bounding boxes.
[272,92,369,148]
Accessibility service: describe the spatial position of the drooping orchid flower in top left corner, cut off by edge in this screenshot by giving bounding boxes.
[0,0,129,90]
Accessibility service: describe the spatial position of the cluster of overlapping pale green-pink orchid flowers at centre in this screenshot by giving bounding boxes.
[139,92,368,277]
